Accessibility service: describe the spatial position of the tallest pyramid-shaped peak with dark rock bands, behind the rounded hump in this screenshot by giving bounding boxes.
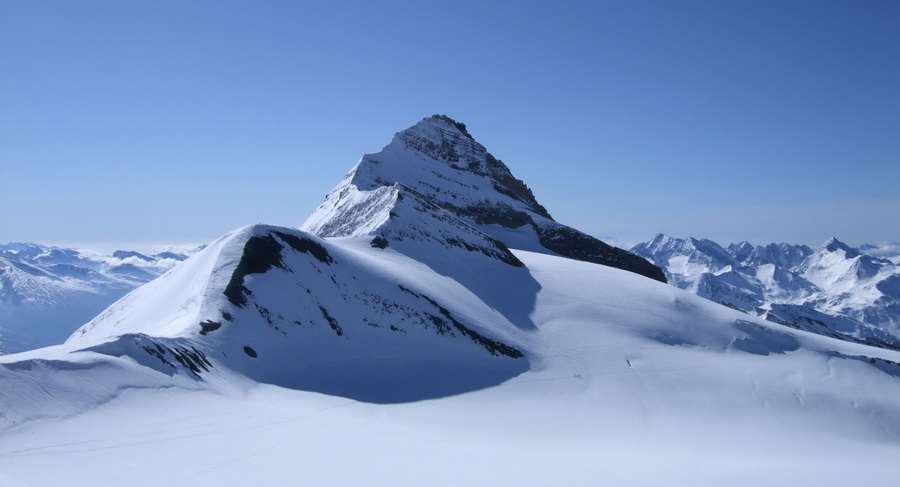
[301,115,666,282]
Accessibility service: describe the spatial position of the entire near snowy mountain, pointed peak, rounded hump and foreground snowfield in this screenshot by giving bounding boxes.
[0,115,900,486]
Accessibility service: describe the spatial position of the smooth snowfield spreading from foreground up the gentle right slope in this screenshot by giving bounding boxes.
[0,239,900,486]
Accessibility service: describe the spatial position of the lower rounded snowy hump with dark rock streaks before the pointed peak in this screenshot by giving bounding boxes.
[59,222,533,402]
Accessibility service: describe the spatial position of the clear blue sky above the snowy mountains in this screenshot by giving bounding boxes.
[0,0,900,252]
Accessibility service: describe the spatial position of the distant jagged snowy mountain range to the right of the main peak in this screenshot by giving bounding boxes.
[631,234,900,348]
